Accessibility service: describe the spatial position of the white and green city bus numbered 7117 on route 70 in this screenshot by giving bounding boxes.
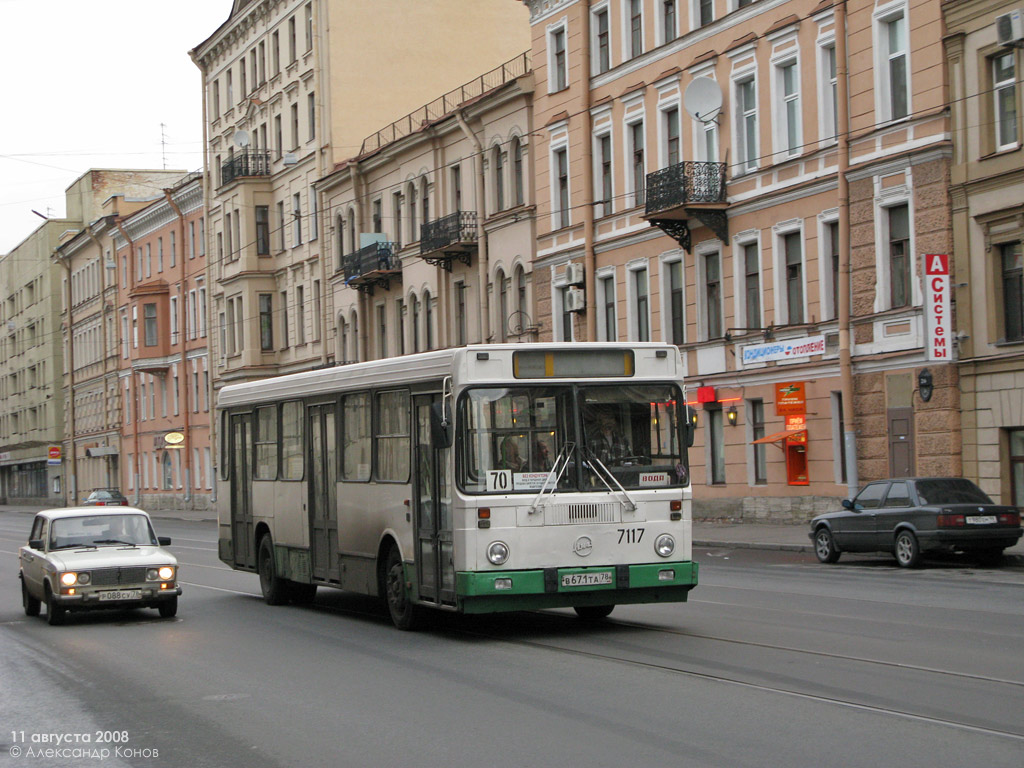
[217,342,697,629]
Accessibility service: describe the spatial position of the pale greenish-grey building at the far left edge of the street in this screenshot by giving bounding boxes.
[0,219,72,504]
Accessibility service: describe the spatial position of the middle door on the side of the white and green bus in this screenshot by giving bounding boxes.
[306,403,341,582]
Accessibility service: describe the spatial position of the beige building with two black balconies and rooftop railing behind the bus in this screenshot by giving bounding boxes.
[325,54,535,361]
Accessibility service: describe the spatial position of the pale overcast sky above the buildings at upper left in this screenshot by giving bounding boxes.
[0,0,231,254]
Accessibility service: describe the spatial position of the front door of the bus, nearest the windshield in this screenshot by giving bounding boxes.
[413,394,456,605]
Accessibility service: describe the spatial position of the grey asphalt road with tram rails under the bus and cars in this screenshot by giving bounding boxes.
[0,513,1024,768]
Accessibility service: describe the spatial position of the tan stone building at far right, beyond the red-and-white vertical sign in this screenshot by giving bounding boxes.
[942,0,1024,506]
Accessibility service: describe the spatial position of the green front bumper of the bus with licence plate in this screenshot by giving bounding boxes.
[456,560,697,613]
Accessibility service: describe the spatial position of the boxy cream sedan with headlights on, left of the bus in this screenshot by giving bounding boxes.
[18,507,181,624]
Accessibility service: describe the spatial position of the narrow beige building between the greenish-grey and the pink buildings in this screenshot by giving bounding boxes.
[55,170,184,503]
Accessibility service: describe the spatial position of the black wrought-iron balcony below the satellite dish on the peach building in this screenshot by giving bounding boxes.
[644,160,729,251]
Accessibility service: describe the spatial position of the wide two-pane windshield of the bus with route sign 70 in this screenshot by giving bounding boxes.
[457,384,689,493]
